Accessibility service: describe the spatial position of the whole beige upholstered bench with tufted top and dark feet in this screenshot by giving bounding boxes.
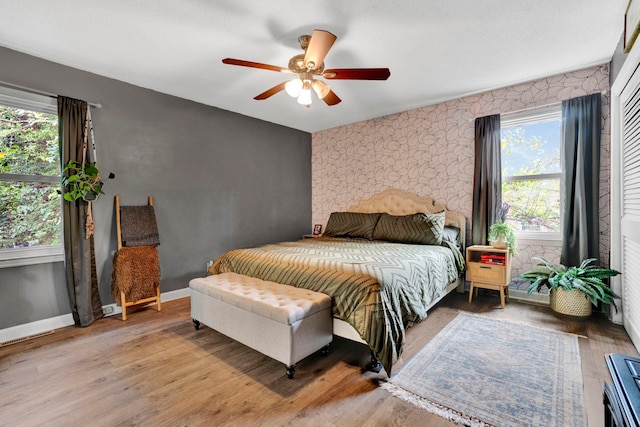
[189,273,333,378]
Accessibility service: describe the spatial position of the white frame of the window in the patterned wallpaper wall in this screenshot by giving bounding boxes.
[500,103,564,243]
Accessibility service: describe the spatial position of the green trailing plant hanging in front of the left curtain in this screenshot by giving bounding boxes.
[62,160,104,202]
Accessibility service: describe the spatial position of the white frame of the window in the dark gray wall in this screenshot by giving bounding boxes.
[0,86,64,268]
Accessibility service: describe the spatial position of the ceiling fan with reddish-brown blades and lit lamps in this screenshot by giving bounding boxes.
[222,30,391,107]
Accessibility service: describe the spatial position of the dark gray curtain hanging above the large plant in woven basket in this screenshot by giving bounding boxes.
[560,93,602,266]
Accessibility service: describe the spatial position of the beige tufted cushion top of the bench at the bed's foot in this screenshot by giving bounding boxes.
[189,273,331,325]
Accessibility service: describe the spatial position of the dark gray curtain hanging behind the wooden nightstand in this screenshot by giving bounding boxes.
[471,114,502,245]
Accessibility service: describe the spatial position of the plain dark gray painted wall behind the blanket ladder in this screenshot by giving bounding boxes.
[0,48,311,329]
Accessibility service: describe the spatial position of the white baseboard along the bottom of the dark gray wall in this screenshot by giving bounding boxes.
[0,288,191,344]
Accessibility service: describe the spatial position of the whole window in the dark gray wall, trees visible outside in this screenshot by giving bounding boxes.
[0,88,63,267]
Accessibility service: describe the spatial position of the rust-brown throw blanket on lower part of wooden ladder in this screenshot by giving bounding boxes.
[111,246,160,305]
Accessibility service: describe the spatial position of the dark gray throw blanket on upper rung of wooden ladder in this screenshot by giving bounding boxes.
[120,205,160,247]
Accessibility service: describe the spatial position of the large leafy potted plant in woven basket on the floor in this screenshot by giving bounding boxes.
[520,257,620,318]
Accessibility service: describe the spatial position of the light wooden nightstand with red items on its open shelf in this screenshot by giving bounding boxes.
[467,245,511,308]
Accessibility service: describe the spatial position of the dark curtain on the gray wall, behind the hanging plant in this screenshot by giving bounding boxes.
[58,96,103,326]
